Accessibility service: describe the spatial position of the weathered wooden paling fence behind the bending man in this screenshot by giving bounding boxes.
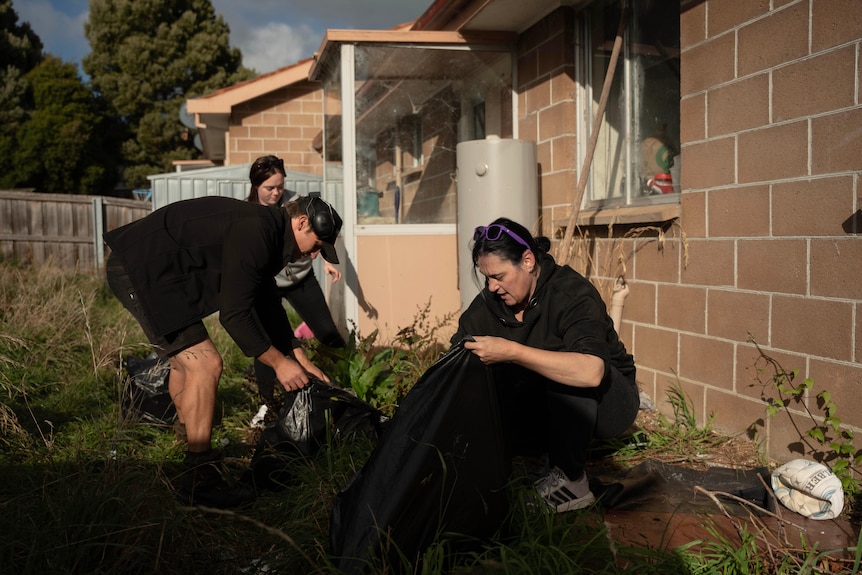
[0,191,152,270]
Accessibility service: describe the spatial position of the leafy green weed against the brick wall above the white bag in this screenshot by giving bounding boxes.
[749,337,862,497]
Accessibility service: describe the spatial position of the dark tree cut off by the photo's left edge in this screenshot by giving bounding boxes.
[0,0,42,187]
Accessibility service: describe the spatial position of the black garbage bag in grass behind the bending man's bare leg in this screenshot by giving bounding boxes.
[123,354,177,425]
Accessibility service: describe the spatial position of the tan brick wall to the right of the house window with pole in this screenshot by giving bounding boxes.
[676,0,862,459]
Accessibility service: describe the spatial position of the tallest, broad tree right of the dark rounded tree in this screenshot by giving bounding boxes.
[82,0,253,187]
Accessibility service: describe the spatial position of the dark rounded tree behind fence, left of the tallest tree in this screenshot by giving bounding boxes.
[12,56,117,194]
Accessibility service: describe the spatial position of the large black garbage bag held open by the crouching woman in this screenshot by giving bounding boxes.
[330,343,511,574]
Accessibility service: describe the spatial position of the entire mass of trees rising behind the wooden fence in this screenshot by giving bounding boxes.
[0,0,253,194]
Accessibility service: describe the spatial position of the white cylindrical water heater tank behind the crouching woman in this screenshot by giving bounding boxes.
[457,136,539,311]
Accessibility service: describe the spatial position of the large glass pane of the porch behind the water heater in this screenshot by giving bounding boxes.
[324,44,512,224]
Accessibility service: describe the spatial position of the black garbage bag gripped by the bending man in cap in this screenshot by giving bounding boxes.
[245,377,381,489]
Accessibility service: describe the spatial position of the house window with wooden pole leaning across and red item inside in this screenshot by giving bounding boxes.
[580,0,681,208]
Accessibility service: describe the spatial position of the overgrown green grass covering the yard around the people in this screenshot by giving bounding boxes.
[0,261,858,575]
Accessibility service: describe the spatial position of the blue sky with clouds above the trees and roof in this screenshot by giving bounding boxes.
[20,0,433,73]
